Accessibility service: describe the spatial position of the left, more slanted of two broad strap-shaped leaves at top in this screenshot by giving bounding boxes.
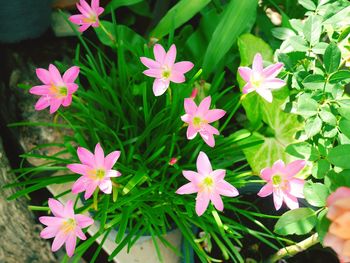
[150,0,210,39]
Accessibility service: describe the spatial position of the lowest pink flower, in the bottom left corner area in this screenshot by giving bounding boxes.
[39,198,94,257]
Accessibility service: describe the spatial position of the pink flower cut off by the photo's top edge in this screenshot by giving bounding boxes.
[69,0,104,32]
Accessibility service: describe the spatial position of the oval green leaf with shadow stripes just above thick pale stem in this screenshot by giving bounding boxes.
[274,208,317,236]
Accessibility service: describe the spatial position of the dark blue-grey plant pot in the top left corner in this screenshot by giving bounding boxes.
[0,0,52,43]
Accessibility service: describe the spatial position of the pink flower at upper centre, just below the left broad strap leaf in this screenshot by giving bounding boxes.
[140,44,193,96]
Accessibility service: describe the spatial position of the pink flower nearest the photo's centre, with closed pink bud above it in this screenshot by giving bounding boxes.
[181,96,226,147]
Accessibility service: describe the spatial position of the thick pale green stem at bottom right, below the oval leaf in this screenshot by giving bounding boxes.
[268,233,320,262]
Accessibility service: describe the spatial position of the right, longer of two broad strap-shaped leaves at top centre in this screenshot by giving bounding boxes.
[202,0,258,74]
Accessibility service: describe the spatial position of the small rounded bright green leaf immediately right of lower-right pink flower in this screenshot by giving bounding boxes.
[304,182,329,207]
